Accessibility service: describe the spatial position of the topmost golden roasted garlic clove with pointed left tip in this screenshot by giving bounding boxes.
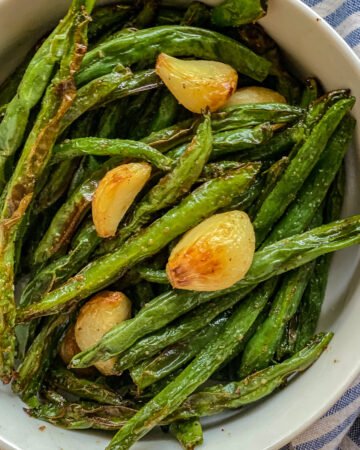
[156,53,238,113]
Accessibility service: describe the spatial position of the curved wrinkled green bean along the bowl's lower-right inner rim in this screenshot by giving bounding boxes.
[170,333,333,421]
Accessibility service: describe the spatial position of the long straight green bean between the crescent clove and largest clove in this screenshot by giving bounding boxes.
[18,164,260,322]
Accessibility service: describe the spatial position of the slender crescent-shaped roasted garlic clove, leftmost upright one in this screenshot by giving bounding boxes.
[92,162,151,238]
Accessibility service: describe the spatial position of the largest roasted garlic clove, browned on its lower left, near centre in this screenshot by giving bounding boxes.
[166,211,255,291]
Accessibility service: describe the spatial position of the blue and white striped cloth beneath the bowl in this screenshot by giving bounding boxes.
[282,0,360,450]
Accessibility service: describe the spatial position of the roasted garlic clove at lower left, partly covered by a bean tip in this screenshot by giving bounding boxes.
[75,291,131,375]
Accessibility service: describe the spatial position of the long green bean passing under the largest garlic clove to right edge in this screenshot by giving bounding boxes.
[66,216,360,367]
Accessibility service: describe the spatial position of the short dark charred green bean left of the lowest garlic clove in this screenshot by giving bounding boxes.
[12,315,69,406]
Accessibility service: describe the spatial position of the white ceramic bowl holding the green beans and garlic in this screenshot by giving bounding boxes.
[0,0,360,450]
